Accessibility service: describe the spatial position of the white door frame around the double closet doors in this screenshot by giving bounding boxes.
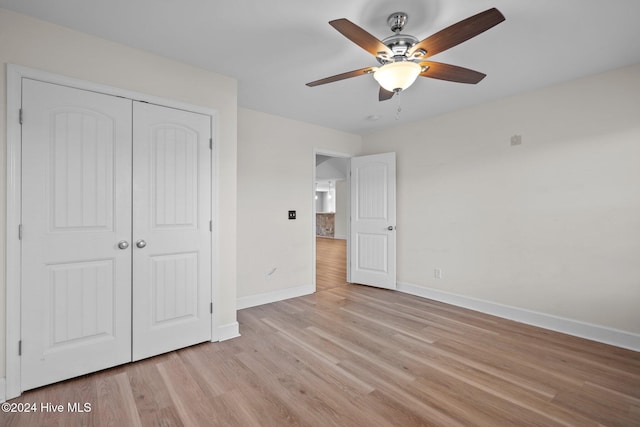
[0,64,220,399]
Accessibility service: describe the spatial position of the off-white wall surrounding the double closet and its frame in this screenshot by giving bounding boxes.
[0,9,237,377]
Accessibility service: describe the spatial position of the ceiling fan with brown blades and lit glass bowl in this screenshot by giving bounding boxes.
[307,8,505,101]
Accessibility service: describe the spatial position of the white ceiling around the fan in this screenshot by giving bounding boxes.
[0,0,640,134]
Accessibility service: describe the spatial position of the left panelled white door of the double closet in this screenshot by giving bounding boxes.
[21,79,131,390]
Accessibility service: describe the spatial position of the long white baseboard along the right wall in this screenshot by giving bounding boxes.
[398,282,640,351]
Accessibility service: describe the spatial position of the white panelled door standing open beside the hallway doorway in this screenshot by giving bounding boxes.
[350,153,396,289]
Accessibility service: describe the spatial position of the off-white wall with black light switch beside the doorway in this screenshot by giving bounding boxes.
[238,108,361,307]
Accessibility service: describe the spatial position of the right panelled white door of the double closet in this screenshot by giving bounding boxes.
[132,102,211,360]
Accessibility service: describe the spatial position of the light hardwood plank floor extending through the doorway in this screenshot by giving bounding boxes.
[0,239,640,427]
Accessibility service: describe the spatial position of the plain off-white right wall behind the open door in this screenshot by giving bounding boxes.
[363,65,640,334]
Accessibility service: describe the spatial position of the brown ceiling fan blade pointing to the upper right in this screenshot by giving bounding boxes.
[407,7,505,58]
